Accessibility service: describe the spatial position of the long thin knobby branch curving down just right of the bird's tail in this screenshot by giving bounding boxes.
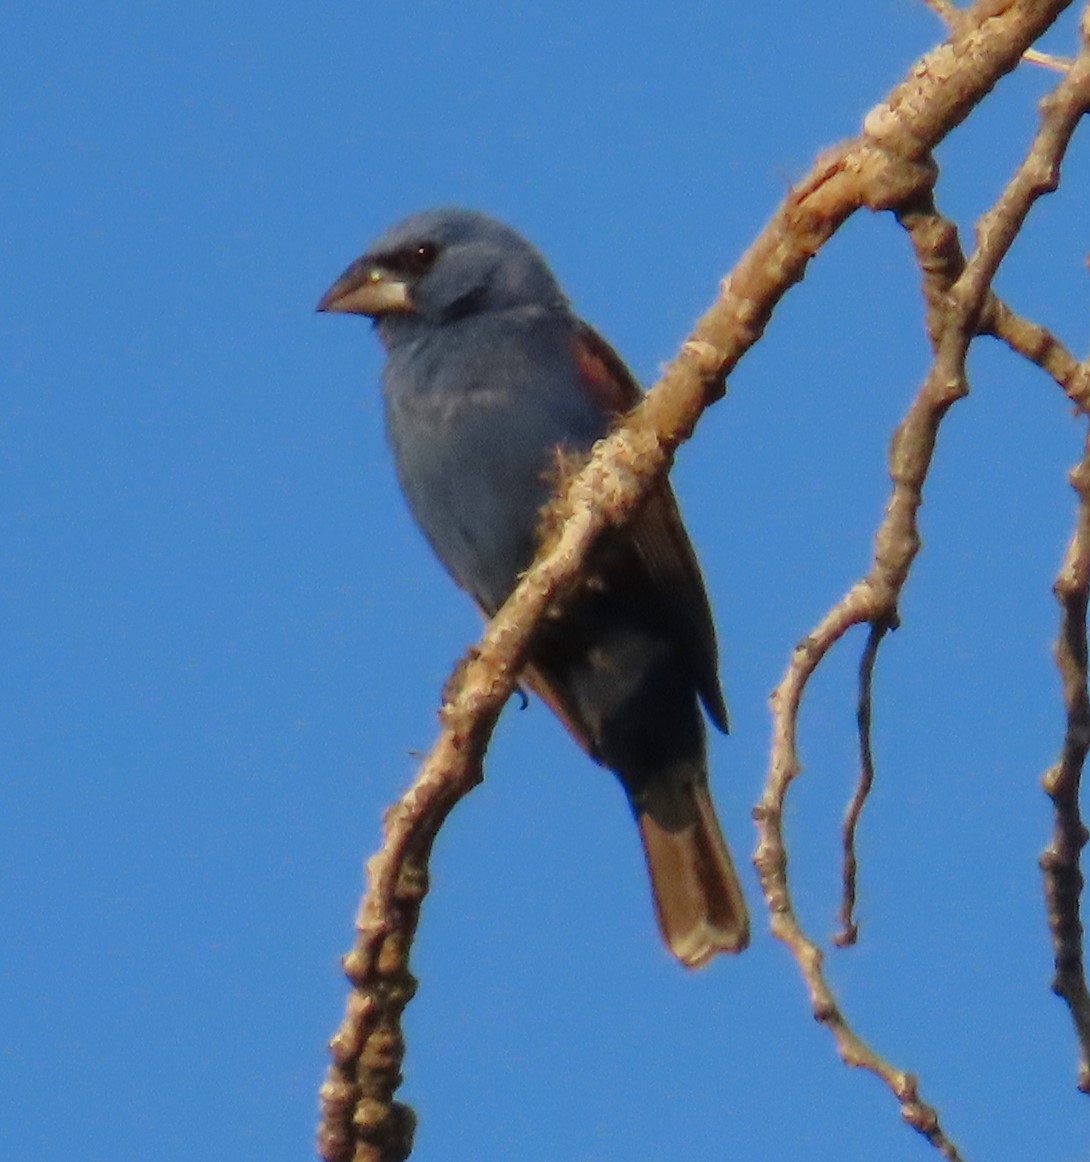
[754,6,1084,1159]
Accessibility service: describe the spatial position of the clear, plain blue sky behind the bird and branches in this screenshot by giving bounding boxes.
[0,0,1090,1162]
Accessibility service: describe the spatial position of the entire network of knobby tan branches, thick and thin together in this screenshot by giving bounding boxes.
[318,0,1090,1162]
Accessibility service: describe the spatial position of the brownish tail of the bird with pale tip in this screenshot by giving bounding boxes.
[636,777,750,968]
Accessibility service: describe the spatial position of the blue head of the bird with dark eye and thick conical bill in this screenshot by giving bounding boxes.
[317,209,566,323]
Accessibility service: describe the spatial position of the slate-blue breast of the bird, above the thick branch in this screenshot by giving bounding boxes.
[383,313,605,612]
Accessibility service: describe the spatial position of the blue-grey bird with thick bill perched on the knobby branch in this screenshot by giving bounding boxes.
[317,207,748,968]
